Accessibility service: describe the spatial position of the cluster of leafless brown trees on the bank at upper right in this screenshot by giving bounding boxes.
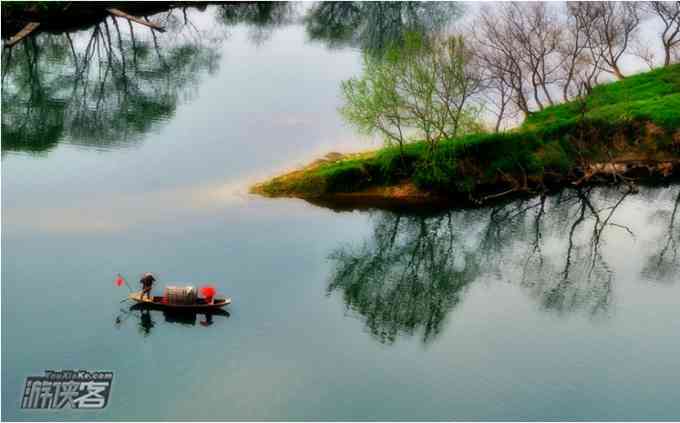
[467,1,680,131]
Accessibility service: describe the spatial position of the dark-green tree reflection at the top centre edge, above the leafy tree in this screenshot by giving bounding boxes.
[305,1,462,53]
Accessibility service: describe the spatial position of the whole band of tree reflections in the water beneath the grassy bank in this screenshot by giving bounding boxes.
[328,187,680,343]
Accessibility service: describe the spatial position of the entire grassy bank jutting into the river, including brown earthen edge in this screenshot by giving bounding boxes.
[253,65,680,207]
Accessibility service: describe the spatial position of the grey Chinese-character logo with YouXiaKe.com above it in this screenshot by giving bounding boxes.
[21,370,113,409]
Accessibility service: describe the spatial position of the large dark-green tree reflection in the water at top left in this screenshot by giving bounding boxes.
[2,4,292,156]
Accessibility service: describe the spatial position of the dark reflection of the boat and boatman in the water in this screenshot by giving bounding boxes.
[115,304,229,336]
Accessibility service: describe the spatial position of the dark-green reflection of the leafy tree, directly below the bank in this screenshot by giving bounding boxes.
[328,213,480,342]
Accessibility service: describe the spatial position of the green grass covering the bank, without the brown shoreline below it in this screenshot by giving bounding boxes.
[263,64,680,199]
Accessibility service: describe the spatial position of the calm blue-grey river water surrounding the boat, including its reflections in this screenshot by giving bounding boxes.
[2,6,680,420]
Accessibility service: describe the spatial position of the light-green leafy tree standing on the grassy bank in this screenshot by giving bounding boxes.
[340,35,482,166]
